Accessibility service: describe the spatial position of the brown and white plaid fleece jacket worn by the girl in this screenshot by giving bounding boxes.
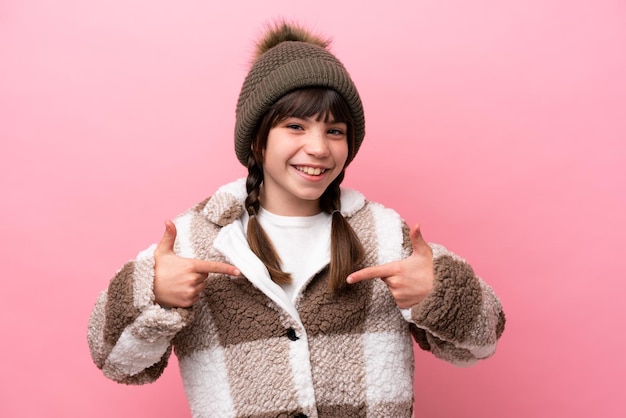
[88,180,504,418]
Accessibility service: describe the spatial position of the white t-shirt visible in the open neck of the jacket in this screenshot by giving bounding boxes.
[257,208,332,301]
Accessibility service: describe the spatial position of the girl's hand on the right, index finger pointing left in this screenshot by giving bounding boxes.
[347,224,435,309]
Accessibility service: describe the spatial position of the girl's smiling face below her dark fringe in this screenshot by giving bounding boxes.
[260,115,348,216]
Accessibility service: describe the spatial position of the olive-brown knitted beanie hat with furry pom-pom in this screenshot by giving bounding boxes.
[235,22,365,166]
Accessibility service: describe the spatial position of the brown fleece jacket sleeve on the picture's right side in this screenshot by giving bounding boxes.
[403,244,505,366]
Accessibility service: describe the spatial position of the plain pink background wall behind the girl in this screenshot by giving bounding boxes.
[0,0,626,418]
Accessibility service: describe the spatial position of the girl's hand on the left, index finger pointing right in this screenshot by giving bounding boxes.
[154,221,240,308]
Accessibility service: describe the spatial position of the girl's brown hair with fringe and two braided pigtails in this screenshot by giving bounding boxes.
[245,87,365,292]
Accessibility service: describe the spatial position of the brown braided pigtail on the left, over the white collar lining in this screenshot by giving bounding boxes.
[245,153,291,284]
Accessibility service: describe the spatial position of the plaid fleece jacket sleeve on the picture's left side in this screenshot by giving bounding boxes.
[87,245,191,384]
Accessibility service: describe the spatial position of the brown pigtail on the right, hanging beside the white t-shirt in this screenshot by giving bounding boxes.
[320,171,365,293]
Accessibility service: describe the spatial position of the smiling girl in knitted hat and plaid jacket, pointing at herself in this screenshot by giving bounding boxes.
[88,23,504,418]
